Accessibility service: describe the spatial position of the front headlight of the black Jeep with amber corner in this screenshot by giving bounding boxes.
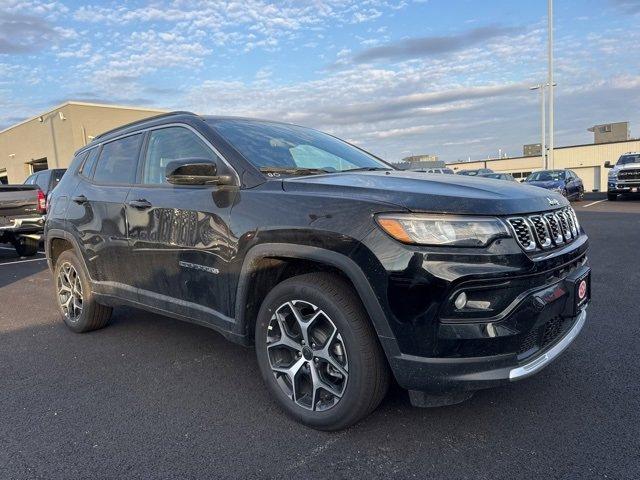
[376,213,510,247]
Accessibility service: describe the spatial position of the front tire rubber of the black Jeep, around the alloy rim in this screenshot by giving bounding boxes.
[255,272,389,430]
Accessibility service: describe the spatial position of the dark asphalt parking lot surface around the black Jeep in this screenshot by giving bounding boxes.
[0,200,640,479]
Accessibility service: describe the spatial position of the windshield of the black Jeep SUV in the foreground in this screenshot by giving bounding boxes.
[210,119,392,175]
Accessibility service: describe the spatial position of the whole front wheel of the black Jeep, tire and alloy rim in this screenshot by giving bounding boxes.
[255,273,389,430]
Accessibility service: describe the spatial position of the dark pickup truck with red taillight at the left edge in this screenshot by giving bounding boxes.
[0,185,46,257]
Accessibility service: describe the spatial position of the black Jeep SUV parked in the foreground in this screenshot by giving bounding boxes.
[45,112,590,430]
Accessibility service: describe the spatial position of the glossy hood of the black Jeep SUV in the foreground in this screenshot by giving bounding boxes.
[282,170,568,215]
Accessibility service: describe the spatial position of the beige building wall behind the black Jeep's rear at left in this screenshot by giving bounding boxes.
[0,102,165,183]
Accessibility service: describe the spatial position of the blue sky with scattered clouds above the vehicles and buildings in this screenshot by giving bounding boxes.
[0,0,640,161]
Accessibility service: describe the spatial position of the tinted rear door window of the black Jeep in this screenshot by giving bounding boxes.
[93,134,142,184]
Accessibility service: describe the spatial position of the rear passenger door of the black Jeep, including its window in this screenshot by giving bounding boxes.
[67,133,143,288]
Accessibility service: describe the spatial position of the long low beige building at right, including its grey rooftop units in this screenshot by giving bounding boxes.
[448,122,640,192]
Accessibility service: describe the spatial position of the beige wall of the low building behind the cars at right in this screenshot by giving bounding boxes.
[448,140,640,192]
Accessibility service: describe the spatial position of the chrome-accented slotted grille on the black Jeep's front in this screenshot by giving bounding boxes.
[507,207,580,252]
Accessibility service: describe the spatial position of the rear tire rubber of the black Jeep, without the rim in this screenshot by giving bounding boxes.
[54,250,112,333]
